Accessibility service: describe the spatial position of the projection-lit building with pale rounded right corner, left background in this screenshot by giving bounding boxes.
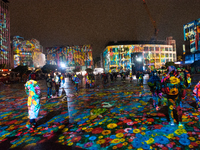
[12,36,45,67]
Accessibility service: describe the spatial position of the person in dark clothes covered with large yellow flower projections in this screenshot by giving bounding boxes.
[161,66,186,126]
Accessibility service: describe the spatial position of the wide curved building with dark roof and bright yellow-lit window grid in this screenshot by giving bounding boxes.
[103,41,176,73]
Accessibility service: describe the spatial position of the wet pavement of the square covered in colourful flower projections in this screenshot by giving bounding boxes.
[0,75,200,150]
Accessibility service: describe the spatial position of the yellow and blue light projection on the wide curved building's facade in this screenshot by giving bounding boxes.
[103,44,176,72]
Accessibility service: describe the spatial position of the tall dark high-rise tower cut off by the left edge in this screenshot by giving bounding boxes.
[0,0,12,68]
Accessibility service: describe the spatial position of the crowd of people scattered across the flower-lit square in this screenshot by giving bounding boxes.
[25,66,200,128]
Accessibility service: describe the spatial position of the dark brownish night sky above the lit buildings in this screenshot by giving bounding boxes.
[9,0,200,57]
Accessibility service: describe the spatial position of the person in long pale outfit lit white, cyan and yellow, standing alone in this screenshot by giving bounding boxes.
[25,75,41,129]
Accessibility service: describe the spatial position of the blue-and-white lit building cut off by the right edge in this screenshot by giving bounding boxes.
[183,18,200,54]
